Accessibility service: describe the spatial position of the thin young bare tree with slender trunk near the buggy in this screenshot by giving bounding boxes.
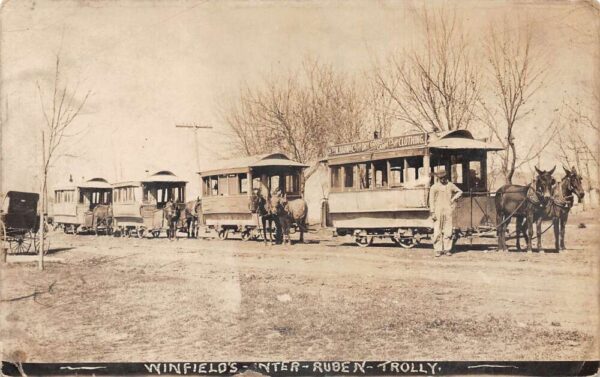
[36,55,90,269]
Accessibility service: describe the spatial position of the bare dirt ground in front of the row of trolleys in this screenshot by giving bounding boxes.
[0,213,600,362]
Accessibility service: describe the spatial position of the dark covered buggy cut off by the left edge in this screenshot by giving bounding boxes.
[0,191,48,254]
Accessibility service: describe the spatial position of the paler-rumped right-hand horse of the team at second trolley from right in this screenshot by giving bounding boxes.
[271,196,308,244]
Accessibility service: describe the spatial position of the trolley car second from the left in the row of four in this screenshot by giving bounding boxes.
[112,170,187,238]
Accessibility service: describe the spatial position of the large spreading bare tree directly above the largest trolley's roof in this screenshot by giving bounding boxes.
[376,5,481,132]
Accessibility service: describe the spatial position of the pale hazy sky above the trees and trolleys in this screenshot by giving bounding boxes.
[0,0,598,197]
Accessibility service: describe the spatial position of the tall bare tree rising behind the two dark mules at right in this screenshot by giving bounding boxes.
[479,21,558,183]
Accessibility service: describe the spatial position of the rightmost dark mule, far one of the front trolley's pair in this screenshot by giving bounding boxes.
[517,166,585,252]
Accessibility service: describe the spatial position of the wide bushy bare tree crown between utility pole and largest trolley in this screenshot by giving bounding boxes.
[223,60,367,162]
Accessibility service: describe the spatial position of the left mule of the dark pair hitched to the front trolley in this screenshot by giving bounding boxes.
[495,167,556,252]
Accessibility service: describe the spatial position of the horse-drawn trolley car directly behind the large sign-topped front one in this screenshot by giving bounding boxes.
[199,153,307,240]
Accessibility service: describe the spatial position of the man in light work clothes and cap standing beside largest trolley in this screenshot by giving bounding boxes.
[429,171,462,257]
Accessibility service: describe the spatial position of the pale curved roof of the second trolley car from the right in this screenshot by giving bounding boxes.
[198,153,308,176]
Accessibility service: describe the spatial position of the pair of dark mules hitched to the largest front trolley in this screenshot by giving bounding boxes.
[496,167,585,253]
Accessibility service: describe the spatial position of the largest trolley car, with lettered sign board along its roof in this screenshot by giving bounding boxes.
[323,130,502,248]
